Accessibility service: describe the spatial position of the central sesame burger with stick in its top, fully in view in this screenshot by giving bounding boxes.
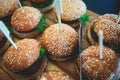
[42,23,78,61]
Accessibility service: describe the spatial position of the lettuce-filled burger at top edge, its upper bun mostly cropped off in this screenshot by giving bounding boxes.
[30,0,55,12]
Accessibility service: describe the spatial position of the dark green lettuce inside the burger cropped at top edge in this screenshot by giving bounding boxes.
[32,0,54,8]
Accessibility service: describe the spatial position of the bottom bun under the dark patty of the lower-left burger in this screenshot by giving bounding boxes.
[10,56,48,80]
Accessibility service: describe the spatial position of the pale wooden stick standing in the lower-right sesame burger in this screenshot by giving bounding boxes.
[98,30,103,59]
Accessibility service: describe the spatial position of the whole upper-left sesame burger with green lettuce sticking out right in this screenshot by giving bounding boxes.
[11,6,46,38]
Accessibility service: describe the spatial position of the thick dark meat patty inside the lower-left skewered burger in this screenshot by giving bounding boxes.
[16,58,43,75]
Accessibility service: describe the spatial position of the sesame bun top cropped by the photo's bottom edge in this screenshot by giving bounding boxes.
[37,70,73,80]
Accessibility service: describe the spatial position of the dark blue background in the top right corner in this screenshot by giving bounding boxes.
[83,0,120,15]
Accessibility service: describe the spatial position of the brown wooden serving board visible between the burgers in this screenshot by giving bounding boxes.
[0,10,99,80]
